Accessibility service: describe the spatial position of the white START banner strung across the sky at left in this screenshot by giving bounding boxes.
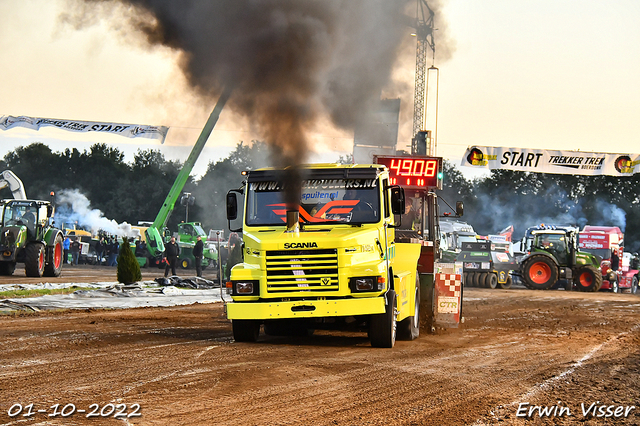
[0,115,169,143]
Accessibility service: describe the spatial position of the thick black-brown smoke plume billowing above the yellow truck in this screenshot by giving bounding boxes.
[64,0,424,166]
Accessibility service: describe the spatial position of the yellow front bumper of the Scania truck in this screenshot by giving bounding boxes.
[227,297,385,320]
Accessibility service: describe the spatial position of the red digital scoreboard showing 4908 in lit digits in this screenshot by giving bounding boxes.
[373,155,442,189]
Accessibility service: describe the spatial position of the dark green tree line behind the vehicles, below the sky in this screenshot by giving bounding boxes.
[0,141,640,251]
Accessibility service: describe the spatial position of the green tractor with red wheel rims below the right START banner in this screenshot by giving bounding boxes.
[520,226,602,291]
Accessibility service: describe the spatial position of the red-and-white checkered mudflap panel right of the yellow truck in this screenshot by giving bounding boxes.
[432,262,464,328]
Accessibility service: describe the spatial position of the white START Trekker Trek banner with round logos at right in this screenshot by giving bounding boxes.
[461,146,640,176]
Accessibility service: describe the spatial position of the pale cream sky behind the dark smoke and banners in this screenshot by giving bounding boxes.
[0,0,640,178]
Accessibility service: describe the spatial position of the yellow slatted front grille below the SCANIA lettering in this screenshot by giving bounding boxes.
[267,249,338,293]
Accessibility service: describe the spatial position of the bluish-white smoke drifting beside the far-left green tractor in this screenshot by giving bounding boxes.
[56,189,140,237]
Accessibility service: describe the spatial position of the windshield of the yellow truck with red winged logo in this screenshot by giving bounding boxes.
[246,179,380,226]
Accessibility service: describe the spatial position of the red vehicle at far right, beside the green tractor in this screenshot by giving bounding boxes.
[579,225,639,293]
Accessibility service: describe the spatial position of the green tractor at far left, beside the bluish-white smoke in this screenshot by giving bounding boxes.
[0,200,63,277]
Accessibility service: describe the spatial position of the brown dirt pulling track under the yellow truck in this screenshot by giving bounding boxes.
[0,268,640,425]
